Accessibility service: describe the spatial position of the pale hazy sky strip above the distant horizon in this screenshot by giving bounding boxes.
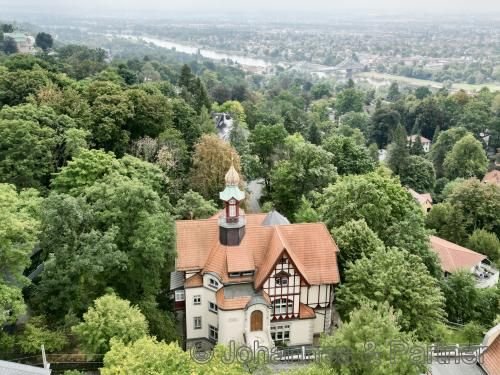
[0,0,500,17]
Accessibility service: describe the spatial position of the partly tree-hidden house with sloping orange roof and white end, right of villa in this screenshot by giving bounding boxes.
[430,236,498,288]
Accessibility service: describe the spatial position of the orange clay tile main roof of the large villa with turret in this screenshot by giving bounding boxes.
[176,214,340,288]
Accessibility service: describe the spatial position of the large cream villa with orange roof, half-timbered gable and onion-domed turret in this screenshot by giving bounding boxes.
[171,167,340,350]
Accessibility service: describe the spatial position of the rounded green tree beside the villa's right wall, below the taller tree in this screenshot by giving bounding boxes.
[337,248,445,340]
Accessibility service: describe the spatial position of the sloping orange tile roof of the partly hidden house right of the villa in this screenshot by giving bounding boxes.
[430,236,486,273]
